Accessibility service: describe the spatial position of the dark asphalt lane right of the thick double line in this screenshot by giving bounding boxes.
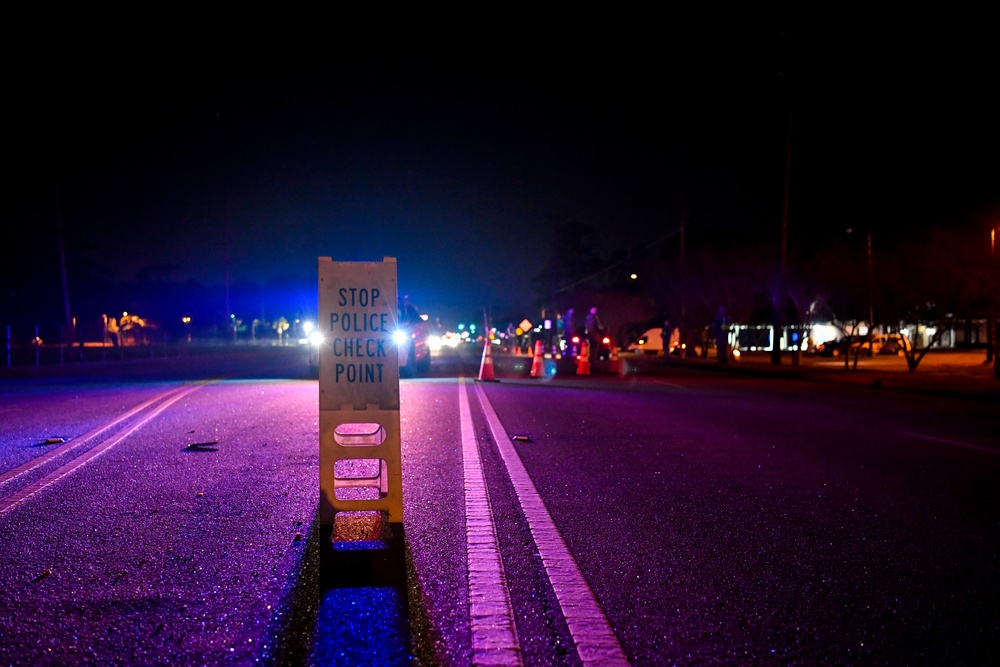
[476,378,1000,665]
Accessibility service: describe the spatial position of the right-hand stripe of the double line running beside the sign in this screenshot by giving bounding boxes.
[476,385,629,667]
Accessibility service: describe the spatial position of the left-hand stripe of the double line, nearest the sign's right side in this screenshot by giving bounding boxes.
[458,377,524,667]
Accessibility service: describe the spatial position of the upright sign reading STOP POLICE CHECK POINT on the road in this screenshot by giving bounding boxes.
[318,257,403,526]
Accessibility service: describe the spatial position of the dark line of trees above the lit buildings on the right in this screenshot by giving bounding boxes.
[536,221,998,370]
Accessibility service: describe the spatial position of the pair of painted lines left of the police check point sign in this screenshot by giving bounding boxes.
[0,383,205,516]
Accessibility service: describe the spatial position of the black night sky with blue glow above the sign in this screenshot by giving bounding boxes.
[2,15,1000,334]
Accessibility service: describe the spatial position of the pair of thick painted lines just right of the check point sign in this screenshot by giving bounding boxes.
[459,378,629,666]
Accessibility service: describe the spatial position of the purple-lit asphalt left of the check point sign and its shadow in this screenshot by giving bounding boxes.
[0,352,317,665]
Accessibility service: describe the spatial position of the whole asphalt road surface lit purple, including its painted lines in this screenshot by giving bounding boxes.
[0,353,1000,665]
